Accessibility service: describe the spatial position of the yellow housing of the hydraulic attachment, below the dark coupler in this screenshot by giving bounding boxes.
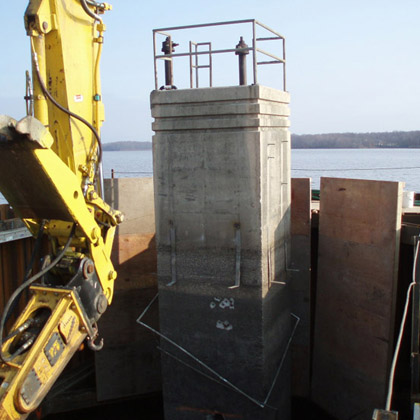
[0,286,90,420]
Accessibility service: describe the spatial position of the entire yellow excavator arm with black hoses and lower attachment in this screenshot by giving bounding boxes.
[0,0,122,420]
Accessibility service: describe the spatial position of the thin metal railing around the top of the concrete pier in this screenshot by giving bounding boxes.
[153,19,286,90]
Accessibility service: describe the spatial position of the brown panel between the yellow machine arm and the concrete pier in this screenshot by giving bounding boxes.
[95,178,161,401]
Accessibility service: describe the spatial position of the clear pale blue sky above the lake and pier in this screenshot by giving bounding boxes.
[0,0,420,142]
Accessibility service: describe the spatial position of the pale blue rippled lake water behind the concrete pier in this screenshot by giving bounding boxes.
[0,149,420,203]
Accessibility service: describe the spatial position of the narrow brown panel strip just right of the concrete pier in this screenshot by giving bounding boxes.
[290,178,311,398]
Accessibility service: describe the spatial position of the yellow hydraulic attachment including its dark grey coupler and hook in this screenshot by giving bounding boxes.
[0,257,108,420]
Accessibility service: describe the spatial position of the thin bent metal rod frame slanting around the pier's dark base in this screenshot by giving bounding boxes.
[137,293,300,410]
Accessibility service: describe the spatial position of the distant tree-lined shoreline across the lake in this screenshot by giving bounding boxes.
[102,131,420,152]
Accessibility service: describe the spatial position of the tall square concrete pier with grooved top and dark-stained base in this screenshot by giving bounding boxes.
[151,85,293,420]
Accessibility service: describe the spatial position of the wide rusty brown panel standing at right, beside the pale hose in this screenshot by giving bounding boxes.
[312,178,403,420]
